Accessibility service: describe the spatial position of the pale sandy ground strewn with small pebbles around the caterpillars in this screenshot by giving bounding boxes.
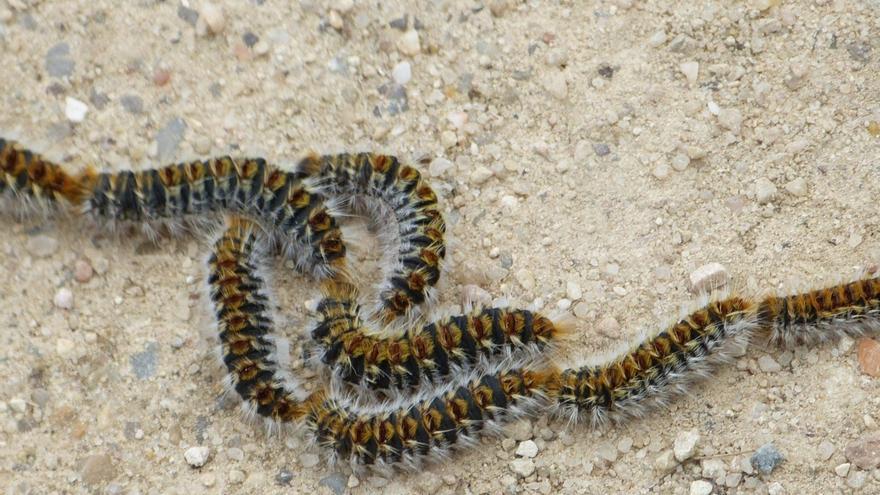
[0,0,880,495]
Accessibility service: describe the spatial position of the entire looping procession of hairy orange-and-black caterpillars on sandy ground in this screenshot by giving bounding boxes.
[0,134,880,471]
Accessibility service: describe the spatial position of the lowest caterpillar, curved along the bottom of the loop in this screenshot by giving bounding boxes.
[308,366,554,472]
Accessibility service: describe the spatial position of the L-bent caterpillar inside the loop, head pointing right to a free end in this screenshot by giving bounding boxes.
[312,280,567,391]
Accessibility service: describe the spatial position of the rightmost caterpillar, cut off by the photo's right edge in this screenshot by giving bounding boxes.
[760,277,880,346]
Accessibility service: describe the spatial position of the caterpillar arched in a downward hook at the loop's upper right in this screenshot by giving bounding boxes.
[300,153,446,325]
